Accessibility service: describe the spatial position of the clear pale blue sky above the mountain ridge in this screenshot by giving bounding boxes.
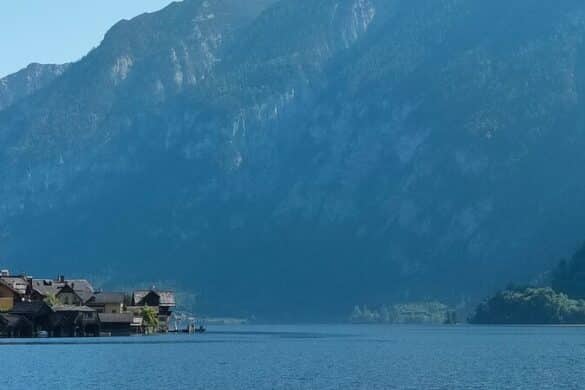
[0,0,176,78]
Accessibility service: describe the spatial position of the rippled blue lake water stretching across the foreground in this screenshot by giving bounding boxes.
[0,325,585,390]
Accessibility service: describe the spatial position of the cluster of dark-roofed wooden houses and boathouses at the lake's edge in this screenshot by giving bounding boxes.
[0,270,176,337]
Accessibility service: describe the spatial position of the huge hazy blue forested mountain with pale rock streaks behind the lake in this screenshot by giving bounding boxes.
[0,0,585,320]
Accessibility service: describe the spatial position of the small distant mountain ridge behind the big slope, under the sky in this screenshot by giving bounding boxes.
[0,64,69,110]
